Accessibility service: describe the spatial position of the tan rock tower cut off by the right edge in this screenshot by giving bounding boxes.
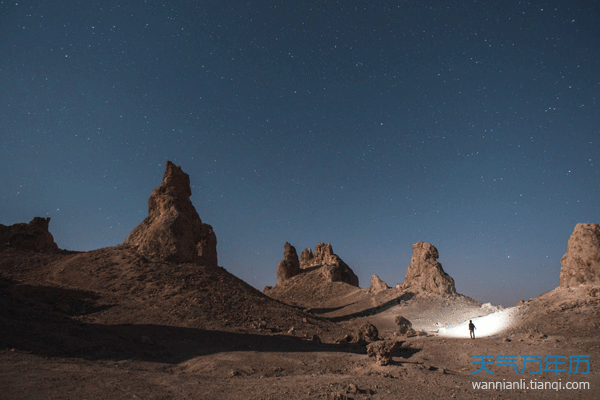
[560,224,600,287]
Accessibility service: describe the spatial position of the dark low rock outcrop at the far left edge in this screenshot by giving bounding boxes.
[0,217,58,252]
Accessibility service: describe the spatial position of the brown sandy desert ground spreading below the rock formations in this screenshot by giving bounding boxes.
[0,249,600,400]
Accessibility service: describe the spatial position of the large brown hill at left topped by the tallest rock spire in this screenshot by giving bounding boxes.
[0,162,333,355]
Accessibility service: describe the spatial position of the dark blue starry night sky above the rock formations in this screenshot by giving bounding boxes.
[0,0,600,306]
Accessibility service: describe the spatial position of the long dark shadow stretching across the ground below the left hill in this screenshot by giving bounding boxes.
[0,277,418,364]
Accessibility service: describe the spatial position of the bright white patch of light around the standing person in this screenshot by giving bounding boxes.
[438,307,518,339]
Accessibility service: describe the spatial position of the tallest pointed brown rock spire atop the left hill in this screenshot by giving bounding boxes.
[124,161,217,265]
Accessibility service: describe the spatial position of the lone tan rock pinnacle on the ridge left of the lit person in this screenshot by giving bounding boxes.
[402,241,456,294]
